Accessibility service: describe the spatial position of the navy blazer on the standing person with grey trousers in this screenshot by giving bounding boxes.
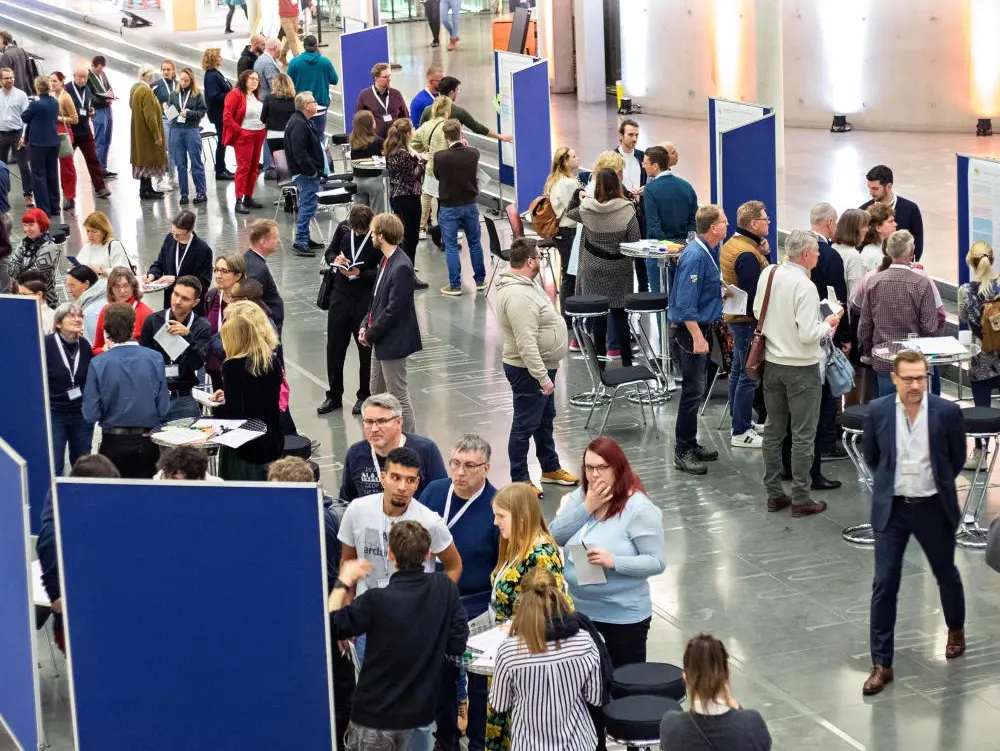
[365,248,423,360]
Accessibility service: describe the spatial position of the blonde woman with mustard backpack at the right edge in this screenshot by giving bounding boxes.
[958,240,1000,469]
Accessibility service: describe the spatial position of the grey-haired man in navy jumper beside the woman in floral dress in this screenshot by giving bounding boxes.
[420,433,500,751]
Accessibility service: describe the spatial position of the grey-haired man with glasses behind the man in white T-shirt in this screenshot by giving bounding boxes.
[340,394,446,506]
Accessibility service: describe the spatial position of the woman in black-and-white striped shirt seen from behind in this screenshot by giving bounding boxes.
[487,569,603,751]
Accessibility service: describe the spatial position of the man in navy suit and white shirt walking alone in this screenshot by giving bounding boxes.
[862,350,966,696]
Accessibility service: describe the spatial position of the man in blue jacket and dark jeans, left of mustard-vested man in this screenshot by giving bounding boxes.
[672,206,729,475]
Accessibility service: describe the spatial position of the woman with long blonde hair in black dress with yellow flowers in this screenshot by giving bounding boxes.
[486,482,572,751]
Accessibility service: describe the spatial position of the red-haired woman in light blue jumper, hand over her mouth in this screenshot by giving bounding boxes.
[549,436,666,668]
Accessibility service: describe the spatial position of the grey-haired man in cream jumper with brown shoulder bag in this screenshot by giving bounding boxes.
[753,230,844,517]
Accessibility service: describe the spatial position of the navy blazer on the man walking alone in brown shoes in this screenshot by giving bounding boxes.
[862,394,966,532]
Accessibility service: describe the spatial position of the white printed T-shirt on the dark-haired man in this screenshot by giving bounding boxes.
[337,493,452,594]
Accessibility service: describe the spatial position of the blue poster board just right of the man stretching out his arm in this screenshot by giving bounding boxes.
[513,60,552,214]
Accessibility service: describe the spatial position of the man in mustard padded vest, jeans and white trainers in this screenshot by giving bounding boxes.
[719,201,771,448]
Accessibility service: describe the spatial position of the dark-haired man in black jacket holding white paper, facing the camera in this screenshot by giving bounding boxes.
[139,276,212,420]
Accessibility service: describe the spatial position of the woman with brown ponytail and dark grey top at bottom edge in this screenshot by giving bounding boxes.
[660,634,771,751]
